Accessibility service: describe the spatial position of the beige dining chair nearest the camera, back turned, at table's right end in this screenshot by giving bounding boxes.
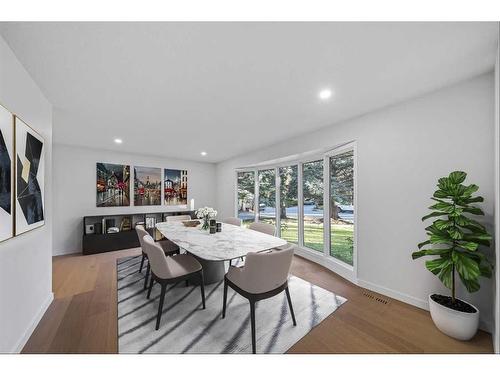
[222,248,297,354]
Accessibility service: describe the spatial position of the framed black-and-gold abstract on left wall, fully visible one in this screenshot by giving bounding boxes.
[15,116,45,236]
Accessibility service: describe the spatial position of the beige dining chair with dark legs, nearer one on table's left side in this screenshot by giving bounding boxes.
[143,236,205,330]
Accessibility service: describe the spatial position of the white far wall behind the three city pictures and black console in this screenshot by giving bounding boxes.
[53,142,215,255]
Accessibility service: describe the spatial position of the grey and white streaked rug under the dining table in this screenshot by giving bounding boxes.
[117,256,347,354]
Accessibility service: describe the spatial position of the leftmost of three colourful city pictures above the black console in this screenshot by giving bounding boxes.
[96,163,130,207]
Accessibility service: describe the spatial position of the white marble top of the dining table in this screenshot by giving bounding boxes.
[156,222,286,261]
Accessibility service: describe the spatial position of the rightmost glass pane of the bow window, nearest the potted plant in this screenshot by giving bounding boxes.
[330,150,354,266]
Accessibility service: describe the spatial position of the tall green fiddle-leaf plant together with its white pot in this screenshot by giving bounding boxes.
[412,171,493,340]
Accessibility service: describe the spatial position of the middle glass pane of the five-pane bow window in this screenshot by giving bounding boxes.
[279,165,299,244]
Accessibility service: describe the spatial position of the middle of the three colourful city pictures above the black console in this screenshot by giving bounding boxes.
[134,167,161,206]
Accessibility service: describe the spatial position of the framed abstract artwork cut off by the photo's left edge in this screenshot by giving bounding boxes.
[0,106,14,242]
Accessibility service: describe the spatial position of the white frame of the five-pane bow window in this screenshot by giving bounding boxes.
[234,141,359,282]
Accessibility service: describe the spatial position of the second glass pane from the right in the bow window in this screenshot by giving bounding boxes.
[302,160,324,252]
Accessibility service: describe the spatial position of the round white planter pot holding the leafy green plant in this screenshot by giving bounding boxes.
[429,295,479,341]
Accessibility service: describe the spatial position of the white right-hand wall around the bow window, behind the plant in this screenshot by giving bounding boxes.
[217,73,494,329]
